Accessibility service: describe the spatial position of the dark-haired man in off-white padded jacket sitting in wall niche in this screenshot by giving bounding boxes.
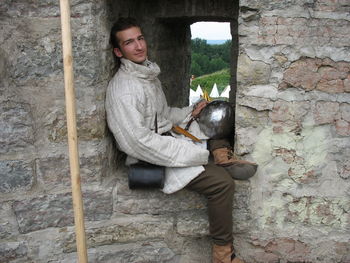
[106,18,256,263]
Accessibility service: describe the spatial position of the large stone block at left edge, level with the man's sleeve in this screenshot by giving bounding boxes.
[0,101,34,153]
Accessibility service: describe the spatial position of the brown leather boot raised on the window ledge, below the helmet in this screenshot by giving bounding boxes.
[212,147,258,180]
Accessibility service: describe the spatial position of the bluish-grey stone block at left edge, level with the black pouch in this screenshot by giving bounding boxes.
[0,160,34,193]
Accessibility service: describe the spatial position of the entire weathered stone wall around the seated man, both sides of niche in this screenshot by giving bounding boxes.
[0,0,350,263]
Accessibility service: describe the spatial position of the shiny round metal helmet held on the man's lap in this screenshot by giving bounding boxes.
[198,100,235,139]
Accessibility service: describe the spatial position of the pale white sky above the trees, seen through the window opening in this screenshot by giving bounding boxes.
[191,22,232,40]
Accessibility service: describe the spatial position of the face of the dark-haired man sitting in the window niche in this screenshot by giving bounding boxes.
[114,27,147,64]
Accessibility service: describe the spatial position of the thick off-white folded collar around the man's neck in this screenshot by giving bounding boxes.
[120,58,160,80]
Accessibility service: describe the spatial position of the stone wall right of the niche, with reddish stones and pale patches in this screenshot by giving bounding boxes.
[236,0,350,262]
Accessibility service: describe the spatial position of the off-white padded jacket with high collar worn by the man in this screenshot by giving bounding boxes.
[106,58,209,193]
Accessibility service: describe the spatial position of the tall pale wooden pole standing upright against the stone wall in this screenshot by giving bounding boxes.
[60,0,87,263]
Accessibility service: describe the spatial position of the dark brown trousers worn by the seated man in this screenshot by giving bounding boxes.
[186,140,235,246]
